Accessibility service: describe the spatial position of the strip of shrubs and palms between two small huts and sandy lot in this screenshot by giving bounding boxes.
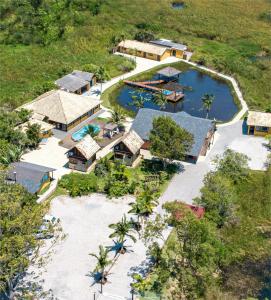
[59,157,177,197]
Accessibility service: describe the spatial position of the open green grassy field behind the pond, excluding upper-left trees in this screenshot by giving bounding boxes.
[0,0,271,110]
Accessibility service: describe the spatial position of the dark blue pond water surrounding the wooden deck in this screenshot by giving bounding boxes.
[117,70,238,122]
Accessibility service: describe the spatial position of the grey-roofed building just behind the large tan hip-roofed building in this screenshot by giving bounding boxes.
[55,70,96,95]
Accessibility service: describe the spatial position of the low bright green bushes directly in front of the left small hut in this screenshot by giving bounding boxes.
[59,173,98,197]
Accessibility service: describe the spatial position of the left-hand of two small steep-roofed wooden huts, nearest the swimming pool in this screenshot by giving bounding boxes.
[68,134,100,172]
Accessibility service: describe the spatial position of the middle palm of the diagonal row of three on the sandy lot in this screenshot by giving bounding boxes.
[108,215,136,254]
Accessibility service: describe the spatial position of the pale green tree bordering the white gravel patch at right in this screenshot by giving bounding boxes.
[214,149,249,183]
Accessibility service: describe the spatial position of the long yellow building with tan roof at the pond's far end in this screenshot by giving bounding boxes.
[117,40,190,61]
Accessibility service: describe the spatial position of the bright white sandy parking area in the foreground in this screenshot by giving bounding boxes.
[24,194,149,300]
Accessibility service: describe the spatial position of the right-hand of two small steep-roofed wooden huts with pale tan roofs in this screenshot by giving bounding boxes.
[114,130,144,166]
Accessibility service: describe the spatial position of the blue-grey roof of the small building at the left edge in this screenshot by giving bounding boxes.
[7,161,55,194]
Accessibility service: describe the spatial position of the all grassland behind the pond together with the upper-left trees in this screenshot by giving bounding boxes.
[0,0,271,110]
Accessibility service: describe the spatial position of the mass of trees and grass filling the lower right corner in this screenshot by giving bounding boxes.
[137,150,271,299]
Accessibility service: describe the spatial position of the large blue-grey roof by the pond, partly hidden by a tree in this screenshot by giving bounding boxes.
[132,108,214,157]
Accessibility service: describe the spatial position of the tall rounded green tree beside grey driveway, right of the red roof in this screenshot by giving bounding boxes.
[194,172,236,228]
